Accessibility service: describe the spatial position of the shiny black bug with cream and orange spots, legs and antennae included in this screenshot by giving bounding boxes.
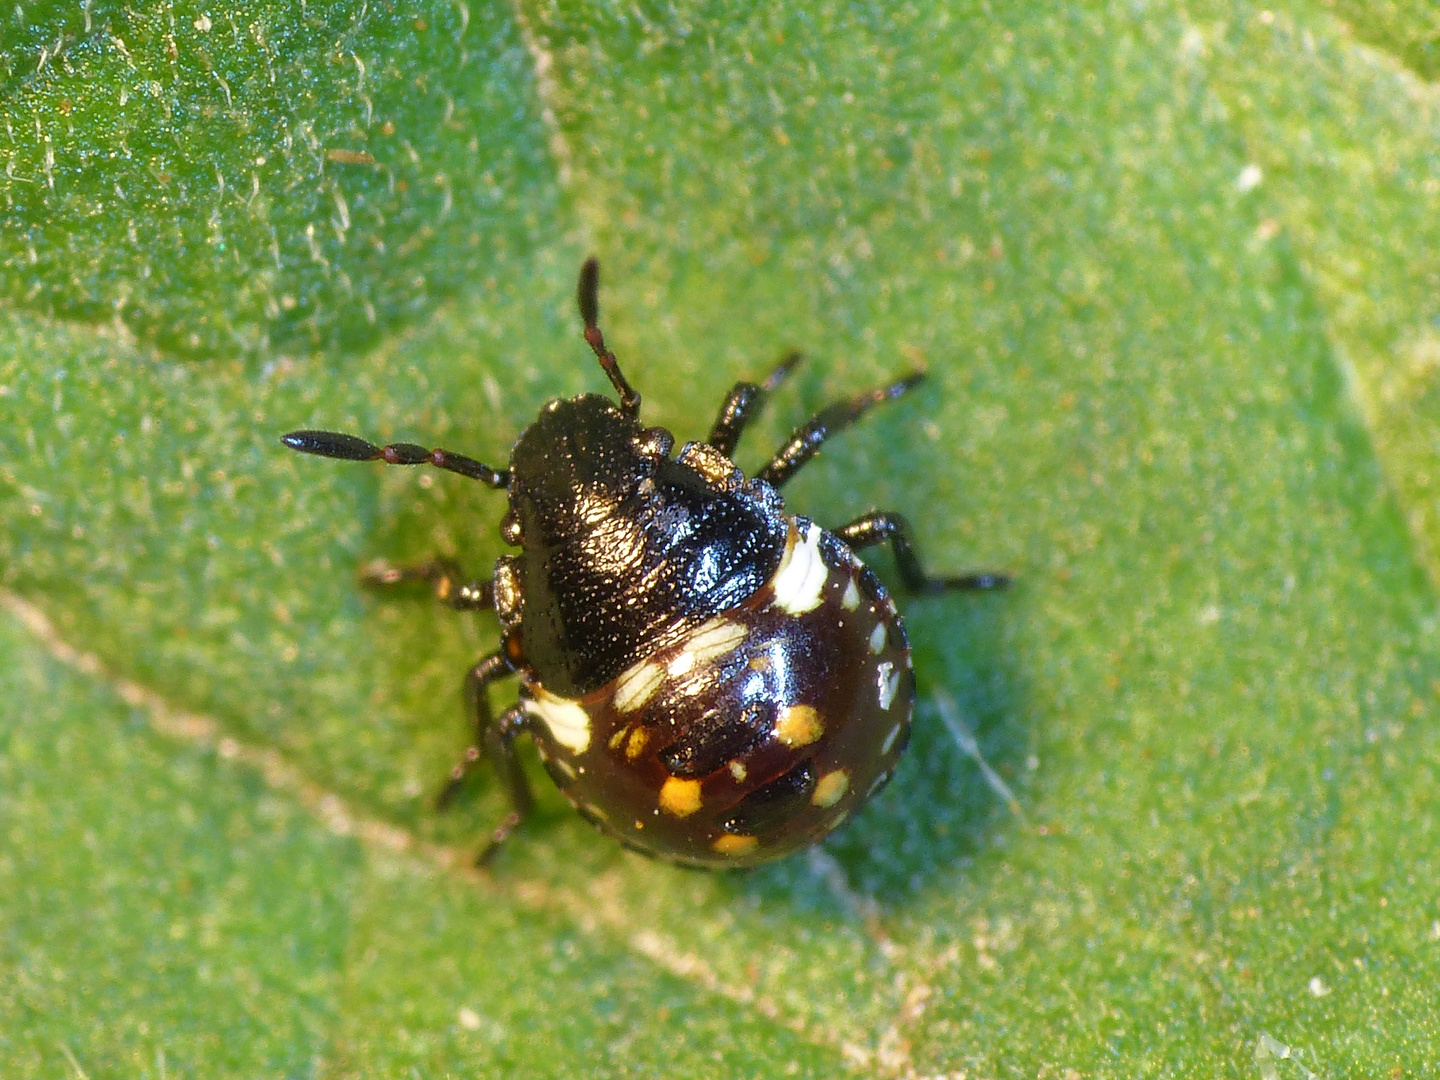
[284,259,1008,867]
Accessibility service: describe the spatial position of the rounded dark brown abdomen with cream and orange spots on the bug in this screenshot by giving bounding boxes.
[523,518,914,867]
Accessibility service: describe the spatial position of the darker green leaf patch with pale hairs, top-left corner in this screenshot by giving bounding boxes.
[0,0,557,357]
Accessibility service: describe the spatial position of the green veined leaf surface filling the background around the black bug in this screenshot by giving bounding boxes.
[0,0,1440,1077]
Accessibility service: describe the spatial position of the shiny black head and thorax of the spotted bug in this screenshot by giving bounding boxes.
[507,395,788,697]
